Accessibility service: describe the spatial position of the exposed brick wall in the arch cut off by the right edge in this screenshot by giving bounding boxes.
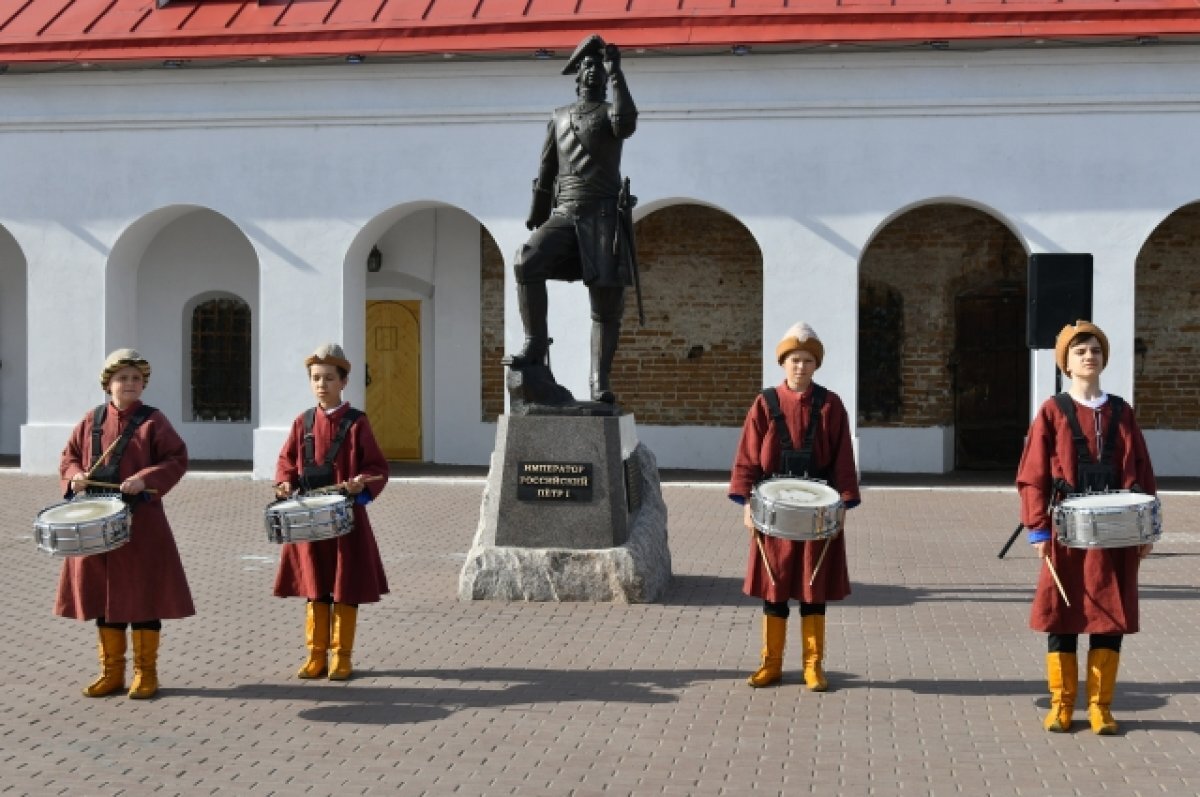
[1133,204,1200,431]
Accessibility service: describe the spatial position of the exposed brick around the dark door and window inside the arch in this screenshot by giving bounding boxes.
[858,204,1027,427]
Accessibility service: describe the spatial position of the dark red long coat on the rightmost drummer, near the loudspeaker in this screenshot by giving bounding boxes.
[1016,399,1158,634]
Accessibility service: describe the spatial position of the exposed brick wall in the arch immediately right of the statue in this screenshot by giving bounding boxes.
[612,205,762,427]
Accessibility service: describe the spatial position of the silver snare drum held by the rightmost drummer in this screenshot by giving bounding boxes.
[1054,491,1163,549]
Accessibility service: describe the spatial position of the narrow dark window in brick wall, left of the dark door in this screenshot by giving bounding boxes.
[858,284,904,423]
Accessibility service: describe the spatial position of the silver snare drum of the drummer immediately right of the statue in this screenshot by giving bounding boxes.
[750,477,846,540]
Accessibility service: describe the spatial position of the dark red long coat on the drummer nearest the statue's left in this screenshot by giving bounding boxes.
[275,403,389,604]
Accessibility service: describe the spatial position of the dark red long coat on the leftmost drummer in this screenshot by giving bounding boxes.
[54,402,196,623]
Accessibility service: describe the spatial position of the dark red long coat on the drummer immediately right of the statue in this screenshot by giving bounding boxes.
[730,382,859,604]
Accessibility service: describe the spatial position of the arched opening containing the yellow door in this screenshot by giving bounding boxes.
[347,202,505,461]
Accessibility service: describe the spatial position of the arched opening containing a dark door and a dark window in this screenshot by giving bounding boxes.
[858,203,1030,469]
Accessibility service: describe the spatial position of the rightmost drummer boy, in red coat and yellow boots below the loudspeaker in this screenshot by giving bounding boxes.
[1016,320,1156,735]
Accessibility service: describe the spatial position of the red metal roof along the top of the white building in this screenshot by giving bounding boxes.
[0,0,1200,64]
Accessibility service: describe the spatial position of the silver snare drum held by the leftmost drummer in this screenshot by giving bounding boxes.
[34,496,131,556]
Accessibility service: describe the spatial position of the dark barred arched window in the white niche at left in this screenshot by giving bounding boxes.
[192,299,250,421]
